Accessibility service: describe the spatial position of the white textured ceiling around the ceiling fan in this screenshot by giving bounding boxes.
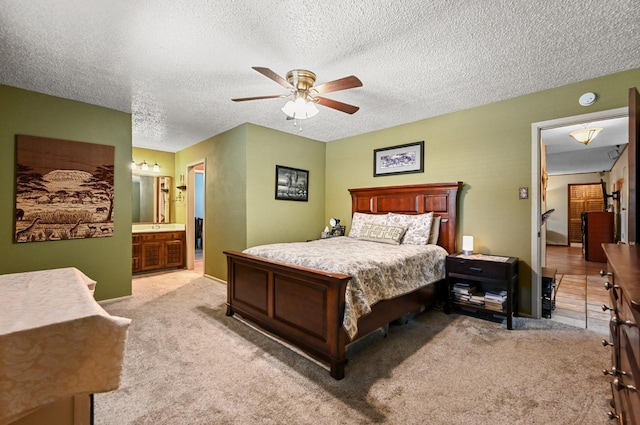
[0,0,640,152]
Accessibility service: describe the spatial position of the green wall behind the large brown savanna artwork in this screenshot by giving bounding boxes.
[0,85,131,300]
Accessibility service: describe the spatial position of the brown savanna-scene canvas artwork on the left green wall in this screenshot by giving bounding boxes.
[14,135,115,243]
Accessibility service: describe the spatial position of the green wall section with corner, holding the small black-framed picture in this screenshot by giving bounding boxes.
[175,124,325,280]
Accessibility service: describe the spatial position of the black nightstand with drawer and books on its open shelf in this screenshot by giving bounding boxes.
[446,254,518,329]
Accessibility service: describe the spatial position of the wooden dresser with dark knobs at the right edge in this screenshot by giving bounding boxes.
[601,244,640,424]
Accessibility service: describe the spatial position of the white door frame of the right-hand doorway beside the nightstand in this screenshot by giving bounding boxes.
[531,106,629,319]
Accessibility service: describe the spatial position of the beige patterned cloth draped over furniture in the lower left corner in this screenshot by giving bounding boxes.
[0,267,130,425]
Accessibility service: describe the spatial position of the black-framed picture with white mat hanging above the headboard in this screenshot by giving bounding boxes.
[373,141,424,177]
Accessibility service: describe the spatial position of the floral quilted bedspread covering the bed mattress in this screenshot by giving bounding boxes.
[244,237,447,338]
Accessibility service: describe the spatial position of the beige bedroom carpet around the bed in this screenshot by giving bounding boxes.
[95,272,611,425]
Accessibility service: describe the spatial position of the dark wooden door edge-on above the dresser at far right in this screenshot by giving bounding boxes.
[627,87,640,243]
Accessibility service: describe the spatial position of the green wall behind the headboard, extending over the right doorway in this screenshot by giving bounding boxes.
[325,69,640,314]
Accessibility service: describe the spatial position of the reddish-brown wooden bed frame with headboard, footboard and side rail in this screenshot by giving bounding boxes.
[224,182,462,379]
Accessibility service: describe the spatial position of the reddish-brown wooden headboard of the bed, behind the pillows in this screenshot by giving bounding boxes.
[349,182,462,254]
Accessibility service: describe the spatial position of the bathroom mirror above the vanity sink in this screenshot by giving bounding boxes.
[132,174,171,223]
